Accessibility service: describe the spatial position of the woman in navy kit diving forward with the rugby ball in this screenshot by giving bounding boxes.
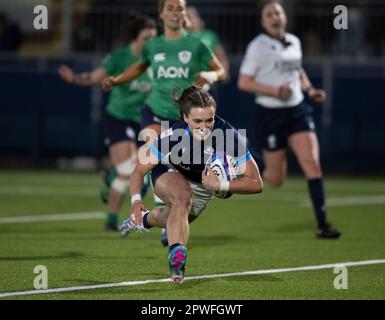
[121,86,262,283]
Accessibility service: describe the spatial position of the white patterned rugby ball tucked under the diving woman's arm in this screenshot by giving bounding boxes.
[210,153,238,199]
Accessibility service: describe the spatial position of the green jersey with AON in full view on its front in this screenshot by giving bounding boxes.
[141,32,214,120]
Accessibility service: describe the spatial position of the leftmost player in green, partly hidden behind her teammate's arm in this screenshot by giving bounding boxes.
[58,13,156,230]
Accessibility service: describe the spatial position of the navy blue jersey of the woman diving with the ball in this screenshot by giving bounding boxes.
[150,116,251,183]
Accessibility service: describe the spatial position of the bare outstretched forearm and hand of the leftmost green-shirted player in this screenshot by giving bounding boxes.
[58,65,108,87]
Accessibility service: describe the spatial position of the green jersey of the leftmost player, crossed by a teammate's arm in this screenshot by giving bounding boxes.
[101,46,151,122]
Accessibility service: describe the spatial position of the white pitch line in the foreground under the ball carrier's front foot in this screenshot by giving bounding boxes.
[0,259,385,298]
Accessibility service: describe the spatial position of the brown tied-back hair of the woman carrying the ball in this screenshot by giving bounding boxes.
[171,84,217,119]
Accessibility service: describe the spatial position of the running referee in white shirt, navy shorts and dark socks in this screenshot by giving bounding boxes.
[238,1,341,238]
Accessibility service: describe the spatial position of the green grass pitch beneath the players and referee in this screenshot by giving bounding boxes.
[0,171,385,300]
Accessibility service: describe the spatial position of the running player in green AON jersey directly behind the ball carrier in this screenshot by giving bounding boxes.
[103,0,227,241]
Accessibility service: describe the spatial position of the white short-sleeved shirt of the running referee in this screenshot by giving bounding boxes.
[240,33,303,108]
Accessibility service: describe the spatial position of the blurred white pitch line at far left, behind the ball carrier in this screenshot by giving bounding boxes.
[0,212,106,224]
